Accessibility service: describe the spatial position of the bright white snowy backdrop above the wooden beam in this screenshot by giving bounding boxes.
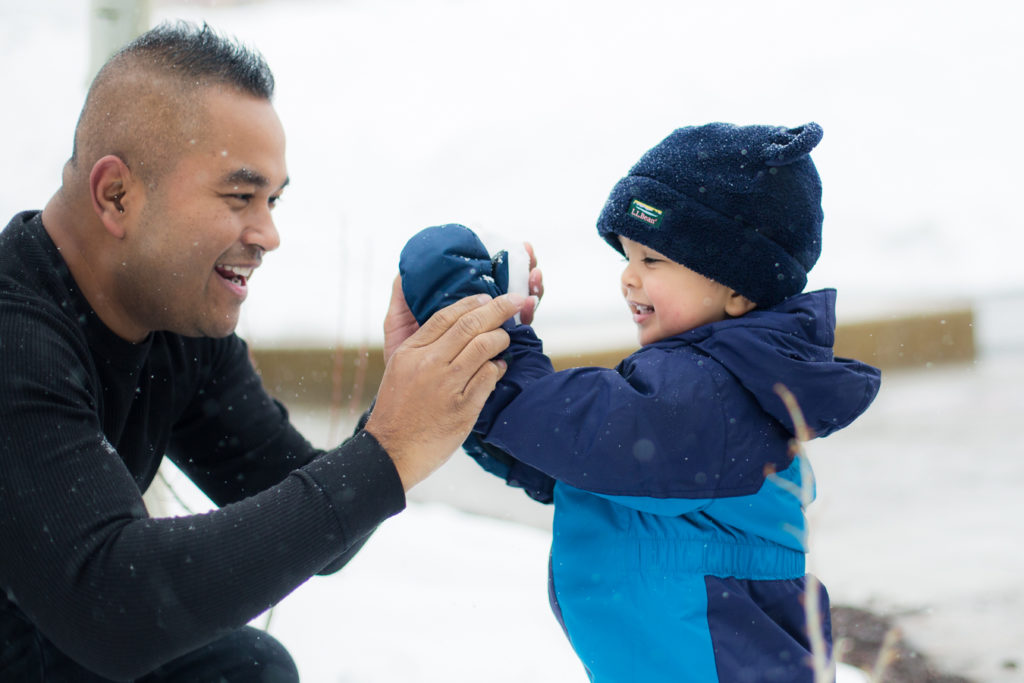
[6,0,1024,351]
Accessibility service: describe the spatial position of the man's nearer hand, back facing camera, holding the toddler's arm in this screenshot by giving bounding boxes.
[366,290,525,490]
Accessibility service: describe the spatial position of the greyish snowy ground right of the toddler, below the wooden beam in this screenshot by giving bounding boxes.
[808,352,1024,681]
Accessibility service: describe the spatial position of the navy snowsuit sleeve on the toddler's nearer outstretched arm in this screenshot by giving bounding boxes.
[482,348,788,501]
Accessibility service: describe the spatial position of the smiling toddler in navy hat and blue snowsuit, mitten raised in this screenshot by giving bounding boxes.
[400,123,880,683]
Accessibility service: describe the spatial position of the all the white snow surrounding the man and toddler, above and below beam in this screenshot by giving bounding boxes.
[0,0,1024,682]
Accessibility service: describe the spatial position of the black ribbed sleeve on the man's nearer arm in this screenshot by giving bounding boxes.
[0,301,404,678]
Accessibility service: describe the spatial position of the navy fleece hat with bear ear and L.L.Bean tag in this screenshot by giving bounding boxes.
[597,123,823,307]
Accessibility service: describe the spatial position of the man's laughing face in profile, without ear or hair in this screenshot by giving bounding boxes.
[116,89,288,337]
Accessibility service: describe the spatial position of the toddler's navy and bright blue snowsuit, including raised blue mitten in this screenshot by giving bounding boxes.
[400,225,880,683]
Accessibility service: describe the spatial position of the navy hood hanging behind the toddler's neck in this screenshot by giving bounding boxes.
[671,289,882,436]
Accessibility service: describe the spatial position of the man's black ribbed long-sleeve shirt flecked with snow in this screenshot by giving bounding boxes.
[0,212,404,678]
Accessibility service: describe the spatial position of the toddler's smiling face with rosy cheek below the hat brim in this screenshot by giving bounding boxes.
[618,237,733,346]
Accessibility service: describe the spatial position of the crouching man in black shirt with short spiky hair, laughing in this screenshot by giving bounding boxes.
[0,25,540,681]
